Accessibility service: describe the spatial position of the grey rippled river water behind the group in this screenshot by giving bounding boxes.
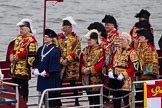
[0,0,162,104]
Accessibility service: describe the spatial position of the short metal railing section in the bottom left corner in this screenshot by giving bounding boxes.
[0,81,19,108]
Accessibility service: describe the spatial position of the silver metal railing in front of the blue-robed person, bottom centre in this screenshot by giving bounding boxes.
[39,84,103,108]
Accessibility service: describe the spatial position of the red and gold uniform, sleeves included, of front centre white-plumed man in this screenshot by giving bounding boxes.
[80,44,105,92]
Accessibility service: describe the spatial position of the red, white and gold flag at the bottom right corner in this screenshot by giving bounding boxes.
[144,80,162,108]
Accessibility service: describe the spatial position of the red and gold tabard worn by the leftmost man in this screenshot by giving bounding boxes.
[9,35,37,79]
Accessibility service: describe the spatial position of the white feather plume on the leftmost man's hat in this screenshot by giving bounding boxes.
[16,18,36,34]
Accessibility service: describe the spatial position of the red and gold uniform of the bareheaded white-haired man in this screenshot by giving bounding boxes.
[109,46,141,91]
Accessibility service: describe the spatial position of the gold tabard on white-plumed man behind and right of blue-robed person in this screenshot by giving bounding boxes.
[57,32,81,80]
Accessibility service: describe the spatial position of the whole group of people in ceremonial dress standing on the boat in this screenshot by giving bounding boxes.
[6,9,159,108]
